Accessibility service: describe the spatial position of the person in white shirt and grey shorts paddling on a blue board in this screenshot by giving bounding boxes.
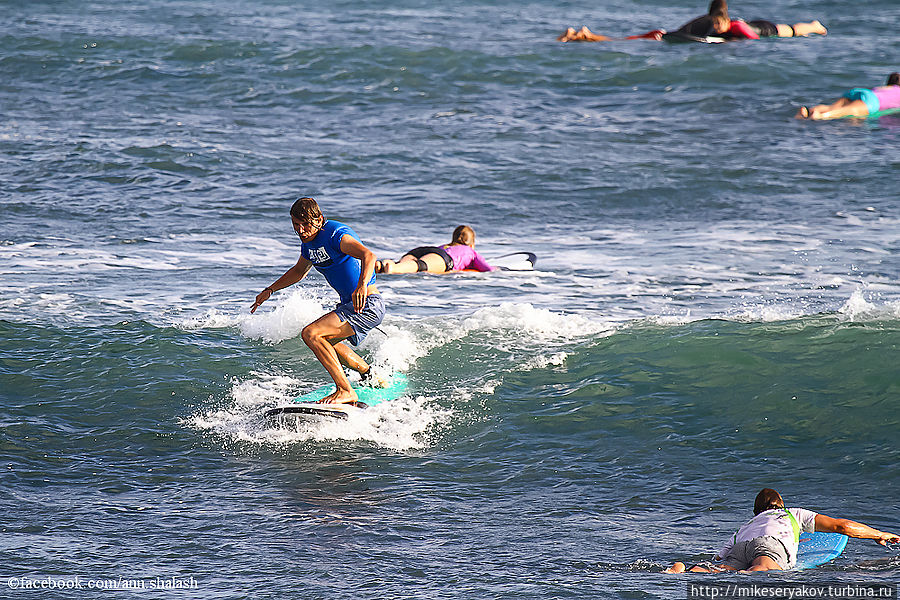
[664,488,900,573]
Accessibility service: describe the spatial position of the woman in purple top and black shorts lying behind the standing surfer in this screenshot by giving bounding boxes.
[375,225,494,274]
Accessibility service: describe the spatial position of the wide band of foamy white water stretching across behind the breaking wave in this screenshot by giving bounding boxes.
[7,212,900,330]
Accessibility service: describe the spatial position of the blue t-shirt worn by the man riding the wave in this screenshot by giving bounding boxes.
[300,221,375,303]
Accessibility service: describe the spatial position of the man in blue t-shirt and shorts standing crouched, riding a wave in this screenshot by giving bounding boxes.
[250,198,385,403]
